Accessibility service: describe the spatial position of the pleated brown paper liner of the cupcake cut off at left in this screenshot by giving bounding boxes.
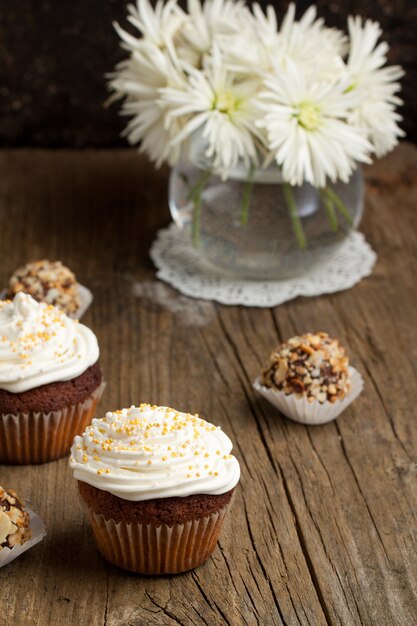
[0,382,106,465]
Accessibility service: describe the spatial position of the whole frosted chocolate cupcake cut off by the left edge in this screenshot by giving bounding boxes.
[0,293,104,464]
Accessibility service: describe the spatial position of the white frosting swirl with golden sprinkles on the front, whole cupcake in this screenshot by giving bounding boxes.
[70,404,240,501]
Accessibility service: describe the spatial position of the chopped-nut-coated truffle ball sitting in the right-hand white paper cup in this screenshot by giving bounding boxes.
[261,332,350,403]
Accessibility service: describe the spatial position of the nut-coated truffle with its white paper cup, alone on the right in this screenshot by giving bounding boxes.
[254,332,363,424]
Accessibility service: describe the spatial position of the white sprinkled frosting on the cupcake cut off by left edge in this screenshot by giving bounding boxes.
[0,293,99,393]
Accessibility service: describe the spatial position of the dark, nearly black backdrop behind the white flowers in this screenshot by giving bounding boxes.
[0,0,417,147]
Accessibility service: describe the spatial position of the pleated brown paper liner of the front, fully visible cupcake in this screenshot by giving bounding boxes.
[84,498,229,575]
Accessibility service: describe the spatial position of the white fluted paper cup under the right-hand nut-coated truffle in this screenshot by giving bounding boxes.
[253,367,364,426]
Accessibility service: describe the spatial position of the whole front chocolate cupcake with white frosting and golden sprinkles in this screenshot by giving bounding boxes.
[70,404,240,574]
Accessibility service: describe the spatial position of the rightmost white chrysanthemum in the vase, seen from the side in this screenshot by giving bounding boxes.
[346,17,404,156]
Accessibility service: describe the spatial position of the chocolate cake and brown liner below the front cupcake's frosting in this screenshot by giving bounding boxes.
[78,482,234,575]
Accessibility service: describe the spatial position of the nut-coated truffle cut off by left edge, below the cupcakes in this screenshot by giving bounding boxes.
[0,487,32,550]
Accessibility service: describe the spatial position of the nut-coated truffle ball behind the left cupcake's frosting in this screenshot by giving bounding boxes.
[7,259,81,315]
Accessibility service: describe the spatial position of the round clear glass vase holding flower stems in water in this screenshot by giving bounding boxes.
[169,155,363,280]
